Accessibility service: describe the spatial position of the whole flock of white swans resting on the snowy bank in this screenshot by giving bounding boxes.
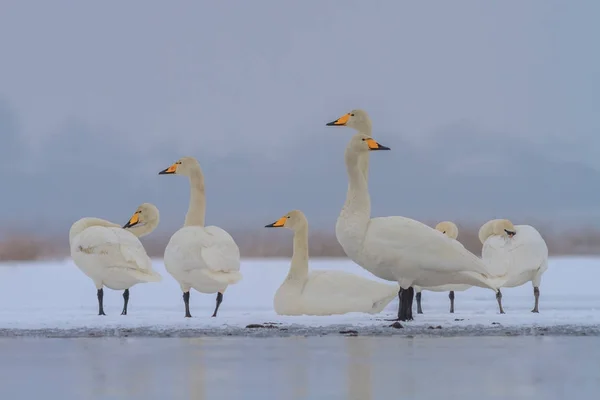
[69,109,548,321]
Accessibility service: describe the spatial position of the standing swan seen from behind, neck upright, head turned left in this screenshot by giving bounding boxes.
[159,157,242,318]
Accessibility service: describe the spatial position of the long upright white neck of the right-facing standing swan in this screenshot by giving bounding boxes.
[339,148,371,235]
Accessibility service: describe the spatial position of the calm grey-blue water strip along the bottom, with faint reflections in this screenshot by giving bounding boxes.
[0,337,600,400]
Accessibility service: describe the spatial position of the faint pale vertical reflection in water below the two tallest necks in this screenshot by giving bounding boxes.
[344,337,371,400]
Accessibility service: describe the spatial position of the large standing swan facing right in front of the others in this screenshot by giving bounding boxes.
[336,131,501,320]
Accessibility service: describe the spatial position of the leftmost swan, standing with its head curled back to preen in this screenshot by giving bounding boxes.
[69,203,162,315]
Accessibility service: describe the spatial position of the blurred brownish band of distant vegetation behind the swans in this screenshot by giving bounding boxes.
[0,223,600,261]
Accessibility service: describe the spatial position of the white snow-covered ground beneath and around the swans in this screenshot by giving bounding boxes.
[0,258,600,337]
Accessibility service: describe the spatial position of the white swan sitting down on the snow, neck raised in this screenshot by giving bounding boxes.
[265,210,398,315]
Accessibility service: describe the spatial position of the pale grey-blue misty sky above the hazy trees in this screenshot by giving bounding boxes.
[0,0,600,231]
